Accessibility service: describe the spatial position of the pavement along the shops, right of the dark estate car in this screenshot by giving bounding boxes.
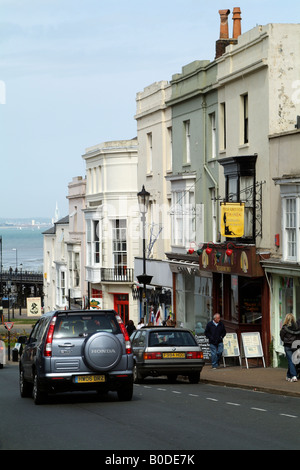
[200,364,300,398]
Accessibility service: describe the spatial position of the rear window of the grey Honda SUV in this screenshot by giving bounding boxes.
[53,314,121,338]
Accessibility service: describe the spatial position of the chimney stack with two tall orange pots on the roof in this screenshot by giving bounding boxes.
[215,7,241,59]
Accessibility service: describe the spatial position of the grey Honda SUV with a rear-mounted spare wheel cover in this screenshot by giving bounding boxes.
[19,310,133,404]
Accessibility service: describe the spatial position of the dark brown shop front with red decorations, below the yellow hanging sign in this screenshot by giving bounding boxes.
[199,243,270,364]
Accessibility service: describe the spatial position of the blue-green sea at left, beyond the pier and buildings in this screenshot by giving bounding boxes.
[0,224,51,273]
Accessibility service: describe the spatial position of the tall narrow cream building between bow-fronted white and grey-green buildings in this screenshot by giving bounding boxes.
[135,81,172,320]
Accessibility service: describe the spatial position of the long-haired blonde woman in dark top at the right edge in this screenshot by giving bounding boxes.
[280,313,300,382]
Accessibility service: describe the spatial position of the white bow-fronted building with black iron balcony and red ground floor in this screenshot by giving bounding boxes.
[82,139,140,324]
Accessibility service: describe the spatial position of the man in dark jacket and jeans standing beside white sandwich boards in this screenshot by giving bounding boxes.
[204,313,226,369]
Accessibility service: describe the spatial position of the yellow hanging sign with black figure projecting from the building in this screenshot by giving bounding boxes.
[221,202,245,238]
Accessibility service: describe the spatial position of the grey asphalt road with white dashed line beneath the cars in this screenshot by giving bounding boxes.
[0,364,300,453]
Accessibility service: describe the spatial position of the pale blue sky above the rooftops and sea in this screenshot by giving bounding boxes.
[0,0,300,219]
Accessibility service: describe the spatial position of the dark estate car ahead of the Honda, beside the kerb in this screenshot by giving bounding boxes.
[130,327,204,383]
